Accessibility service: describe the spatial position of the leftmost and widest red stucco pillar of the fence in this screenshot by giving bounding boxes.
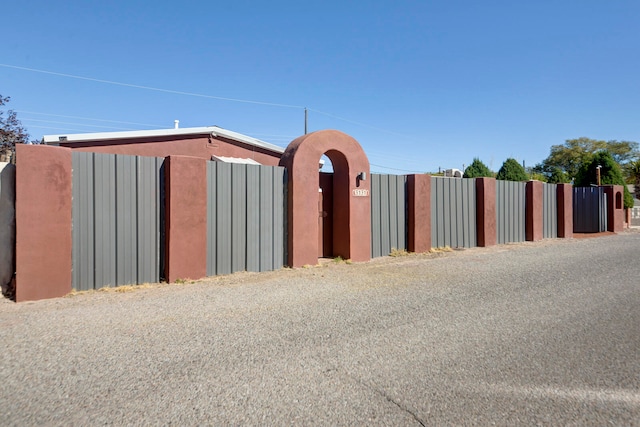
[16,144,72,302]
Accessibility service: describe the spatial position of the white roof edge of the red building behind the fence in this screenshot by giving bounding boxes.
[42,126,284,153]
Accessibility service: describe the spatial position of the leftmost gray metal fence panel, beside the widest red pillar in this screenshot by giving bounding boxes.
[72,151,164,290]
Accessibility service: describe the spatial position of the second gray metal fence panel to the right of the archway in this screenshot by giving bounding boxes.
[431,177,478,248]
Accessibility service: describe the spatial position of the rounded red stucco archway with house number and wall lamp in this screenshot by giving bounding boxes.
[280,130,371,267]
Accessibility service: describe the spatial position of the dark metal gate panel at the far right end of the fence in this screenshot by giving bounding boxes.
[573,187,607,233]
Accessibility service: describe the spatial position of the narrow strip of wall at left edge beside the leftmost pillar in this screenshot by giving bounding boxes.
[0,162,16,292]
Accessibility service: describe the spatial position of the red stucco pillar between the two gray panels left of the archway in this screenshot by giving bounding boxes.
[164,156,207,283]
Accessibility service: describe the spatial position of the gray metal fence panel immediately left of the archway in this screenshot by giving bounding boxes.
[207,162,286,276]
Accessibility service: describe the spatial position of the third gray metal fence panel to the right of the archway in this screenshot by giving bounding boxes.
[496,180,526,244]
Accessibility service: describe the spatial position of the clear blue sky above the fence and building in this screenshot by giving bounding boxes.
[0,0,640,173]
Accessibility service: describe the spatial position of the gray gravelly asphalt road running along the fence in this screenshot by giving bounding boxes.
[0,233,640,426]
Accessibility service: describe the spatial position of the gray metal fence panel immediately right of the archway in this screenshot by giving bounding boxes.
[371,174,407,258]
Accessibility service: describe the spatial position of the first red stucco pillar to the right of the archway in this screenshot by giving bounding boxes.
[407,175,431,253]
